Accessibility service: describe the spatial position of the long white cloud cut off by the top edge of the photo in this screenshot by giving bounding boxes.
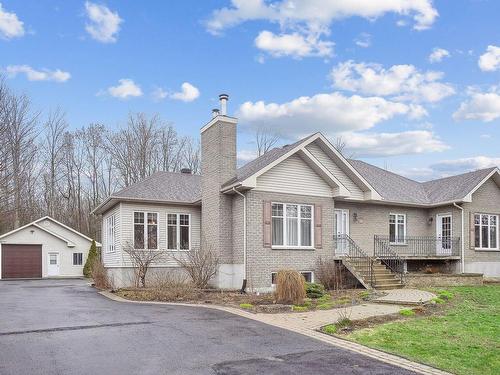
[207,0,438,34]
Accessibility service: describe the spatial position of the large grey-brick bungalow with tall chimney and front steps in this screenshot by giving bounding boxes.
[94,95,500,290]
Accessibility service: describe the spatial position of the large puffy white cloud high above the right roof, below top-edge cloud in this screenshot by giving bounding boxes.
[330,60,455,102]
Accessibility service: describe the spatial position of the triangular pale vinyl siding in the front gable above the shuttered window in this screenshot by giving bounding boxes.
[255,155,333,197]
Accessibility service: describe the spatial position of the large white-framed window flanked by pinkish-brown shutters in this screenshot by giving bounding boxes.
[271,203,313,247]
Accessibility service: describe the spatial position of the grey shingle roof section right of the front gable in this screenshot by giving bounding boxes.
[349,160,495,204]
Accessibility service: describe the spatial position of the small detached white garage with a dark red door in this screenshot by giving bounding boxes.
[0,216,101,279]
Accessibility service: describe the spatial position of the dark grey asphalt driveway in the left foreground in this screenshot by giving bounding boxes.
[0,280,412,375]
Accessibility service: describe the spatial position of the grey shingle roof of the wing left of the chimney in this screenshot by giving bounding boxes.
[111,172,201,203]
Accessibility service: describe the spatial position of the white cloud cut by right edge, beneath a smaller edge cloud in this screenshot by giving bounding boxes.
[453,88,500,122]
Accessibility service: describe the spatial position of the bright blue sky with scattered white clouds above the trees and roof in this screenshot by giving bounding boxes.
[0,0,500,179]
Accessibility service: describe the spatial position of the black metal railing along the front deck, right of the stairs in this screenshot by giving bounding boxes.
[374,236,460,257]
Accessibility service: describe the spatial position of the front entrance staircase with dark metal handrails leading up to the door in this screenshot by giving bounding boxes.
[336,235,404,289]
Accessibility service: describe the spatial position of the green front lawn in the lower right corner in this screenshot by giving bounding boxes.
[348,285,500,375]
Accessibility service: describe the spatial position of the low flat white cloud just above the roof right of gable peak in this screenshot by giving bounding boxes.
[341,130,450,157]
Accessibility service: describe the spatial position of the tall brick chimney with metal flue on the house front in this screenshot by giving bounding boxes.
[201,94,237,278]
